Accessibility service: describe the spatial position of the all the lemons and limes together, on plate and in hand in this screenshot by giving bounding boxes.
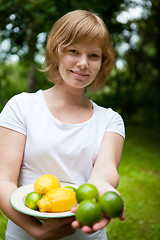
[25,174,124,226]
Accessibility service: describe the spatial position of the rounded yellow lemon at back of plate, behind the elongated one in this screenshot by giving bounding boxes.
[34,174,61,194]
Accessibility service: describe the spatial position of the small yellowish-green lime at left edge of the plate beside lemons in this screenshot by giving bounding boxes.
[25,192,42,211]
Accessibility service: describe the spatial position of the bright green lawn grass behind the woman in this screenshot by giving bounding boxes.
[0,127,160,240]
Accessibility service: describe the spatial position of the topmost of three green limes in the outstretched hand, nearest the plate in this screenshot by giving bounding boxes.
[76,183,99,203]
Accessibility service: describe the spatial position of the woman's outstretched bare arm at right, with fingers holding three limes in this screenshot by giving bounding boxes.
[72,132,124,233]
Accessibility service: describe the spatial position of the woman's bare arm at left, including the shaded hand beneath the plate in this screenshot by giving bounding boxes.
[0,127,74,240]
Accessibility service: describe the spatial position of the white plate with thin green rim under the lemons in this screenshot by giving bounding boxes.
[9,182,77,219]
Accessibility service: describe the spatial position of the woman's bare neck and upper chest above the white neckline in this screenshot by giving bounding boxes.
[43,85,93,124]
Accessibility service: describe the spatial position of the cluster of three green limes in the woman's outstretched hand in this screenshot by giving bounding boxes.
[76,183,124,226]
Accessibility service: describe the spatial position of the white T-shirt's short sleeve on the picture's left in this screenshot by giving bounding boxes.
[0,94,26,135]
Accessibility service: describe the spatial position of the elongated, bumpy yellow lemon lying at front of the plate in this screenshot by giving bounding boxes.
[38,188,77,213]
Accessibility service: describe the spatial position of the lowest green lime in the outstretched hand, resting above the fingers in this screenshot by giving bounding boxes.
[75,199,102,227]
